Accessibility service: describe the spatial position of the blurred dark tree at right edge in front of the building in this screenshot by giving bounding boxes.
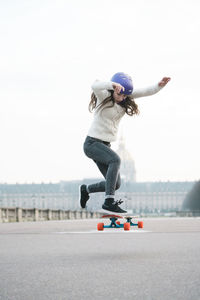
[183,180,200,210]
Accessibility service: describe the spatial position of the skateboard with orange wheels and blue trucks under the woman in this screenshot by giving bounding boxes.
[97,215,143,231]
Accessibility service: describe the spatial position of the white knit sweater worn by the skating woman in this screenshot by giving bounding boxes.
[88,80,162,142]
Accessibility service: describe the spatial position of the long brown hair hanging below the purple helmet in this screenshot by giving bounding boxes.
[88,90,140,116]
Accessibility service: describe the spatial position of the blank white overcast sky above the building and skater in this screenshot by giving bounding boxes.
[0,0,200,183]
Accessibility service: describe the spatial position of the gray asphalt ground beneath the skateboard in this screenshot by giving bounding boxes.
[0,218,200,300]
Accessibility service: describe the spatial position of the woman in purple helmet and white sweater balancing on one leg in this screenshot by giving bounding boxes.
[80,72,170,213]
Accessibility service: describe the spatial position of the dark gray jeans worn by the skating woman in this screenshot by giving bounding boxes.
[83,136,121,196]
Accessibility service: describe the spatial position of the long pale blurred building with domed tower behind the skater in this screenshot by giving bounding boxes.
[0,136,195,213]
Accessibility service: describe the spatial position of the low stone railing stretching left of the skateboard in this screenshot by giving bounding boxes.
[0,207,102,223]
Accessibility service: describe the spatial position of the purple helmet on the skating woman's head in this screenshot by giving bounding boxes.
[111,72,133,95]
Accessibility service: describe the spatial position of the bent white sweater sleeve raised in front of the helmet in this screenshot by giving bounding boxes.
[91,80,113,102]
